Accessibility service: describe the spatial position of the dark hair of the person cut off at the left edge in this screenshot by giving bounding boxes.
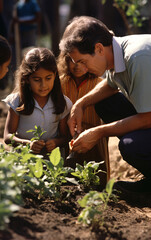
[0,35,12,65]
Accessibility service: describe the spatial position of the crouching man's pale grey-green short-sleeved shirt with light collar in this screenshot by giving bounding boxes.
[107,34,151,113]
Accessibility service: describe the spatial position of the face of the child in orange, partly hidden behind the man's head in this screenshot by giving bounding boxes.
[69,60,88,78]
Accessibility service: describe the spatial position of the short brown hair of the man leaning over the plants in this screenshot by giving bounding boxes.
[59,16,114,54]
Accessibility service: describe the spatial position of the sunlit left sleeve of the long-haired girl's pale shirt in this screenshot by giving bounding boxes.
[2,93,19,115]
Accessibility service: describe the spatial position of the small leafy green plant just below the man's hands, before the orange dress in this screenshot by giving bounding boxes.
[71,161,104,187]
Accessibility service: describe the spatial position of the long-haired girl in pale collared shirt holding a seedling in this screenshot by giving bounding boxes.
[4,48,72,153]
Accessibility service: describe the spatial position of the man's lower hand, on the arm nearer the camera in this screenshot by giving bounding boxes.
[72,128,100,153]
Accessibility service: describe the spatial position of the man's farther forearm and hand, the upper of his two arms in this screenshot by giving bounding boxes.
[68,79,118,136]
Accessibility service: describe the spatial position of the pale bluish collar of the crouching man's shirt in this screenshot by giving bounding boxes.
[113,36,126,73]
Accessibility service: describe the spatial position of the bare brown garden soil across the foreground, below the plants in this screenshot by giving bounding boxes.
[0,182,151,240]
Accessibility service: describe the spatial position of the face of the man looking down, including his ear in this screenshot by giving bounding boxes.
[70,45,108,76]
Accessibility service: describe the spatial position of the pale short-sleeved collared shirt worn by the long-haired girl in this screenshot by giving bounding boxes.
[3,93,72,141]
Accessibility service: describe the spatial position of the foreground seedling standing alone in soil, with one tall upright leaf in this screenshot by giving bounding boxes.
[78,179,117,226]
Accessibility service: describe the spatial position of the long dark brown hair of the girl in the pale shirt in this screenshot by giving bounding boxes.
[14,48,66,115]
